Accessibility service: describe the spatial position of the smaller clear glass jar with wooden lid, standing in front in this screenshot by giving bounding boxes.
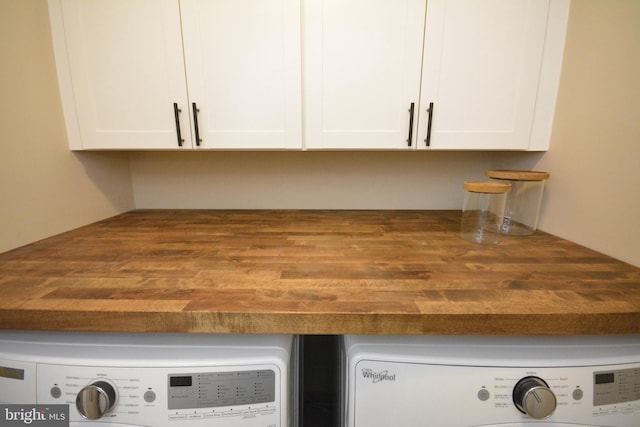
[460,181,511,244]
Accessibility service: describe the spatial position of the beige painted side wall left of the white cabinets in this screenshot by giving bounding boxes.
[0,0,134,252]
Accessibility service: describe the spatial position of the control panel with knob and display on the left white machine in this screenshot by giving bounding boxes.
[25,364,286,427]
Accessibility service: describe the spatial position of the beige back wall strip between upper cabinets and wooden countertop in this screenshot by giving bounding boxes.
[131,152,491,209]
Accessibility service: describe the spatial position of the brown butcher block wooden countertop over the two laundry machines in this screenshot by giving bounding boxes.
[0,210,640,335]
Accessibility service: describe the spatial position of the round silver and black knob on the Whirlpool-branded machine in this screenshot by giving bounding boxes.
[513,377,557,420]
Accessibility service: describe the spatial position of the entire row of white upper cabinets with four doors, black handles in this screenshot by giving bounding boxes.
[49,0,569,150]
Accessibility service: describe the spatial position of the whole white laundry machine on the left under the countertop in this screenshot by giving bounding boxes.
[0,331,298,427]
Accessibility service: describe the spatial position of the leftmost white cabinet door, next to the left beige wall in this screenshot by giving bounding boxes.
[49,0,191,149]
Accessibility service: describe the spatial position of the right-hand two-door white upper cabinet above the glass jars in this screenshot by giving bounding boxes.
[303,0,569,150]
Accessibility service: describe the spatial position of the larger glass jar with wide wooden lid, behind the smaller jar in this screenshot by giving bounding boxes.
[485,170,549,236]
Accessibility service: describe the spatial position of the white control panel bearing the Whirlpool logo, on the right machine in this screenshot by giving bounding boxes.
[347,358,640,427]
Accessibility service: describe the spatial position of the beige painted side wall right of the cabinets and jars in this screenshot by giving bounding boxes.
[495,0,640,266]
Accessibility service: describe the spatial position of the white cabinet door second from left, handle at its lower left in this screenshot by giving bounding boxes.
[181,0,302,149]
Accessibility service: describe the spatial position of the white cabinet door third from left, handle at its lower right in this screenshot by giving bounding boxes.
[303,0,426,149]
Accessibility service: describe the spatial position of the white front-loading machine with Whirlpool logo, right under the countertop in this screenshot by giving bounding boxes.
[341,335,640,427]
